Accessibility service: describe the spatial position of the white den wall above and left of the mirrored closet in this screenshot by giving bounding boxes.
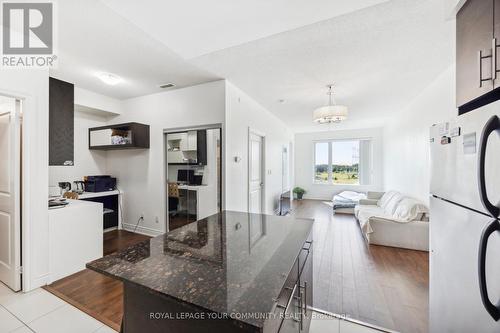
[107,81,225,234]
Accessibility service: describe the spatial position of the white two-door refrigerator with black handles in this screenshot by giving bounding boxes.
[429,102,500,333]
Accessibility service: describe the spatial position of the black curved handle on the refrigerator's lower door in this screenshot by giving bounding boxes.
[478,220,500,321]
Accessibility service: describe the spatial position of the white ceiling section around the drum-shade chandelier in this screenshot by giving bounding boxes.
[193,0,455,132]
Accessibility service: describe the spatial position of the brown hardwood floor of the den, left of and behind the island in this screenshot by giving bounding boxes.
[45,230,151,331]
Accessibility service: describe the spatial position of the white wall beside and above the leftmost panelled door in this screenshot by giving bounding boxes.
[0,69,49,290]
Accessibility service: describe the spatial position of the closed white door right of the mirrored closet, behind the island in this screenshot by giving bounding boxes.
[248,132,264,214]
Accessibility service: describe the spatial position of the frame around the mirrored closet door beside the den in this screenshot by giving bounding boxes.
[162,123,226,232]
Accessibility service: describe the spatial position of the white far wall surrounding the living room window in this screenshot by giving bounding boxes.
[295,128,383,200]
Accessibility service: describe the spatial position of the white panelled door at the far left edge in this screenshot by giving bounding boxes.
[0,96,21,291]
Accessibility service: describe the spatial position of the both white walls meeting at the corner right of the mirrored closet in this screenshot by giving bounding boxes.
[107,81,293,234]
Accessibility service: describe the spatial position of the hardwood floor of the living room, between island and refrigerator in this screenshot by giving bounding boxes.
[292,200,429,333]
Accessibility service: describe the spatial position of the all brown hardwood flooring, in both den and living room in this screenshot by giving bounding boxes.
[46,200,429,333]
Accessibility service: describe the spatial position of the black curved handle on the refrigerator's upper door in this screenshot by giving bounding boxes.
[478,116,500,218]
